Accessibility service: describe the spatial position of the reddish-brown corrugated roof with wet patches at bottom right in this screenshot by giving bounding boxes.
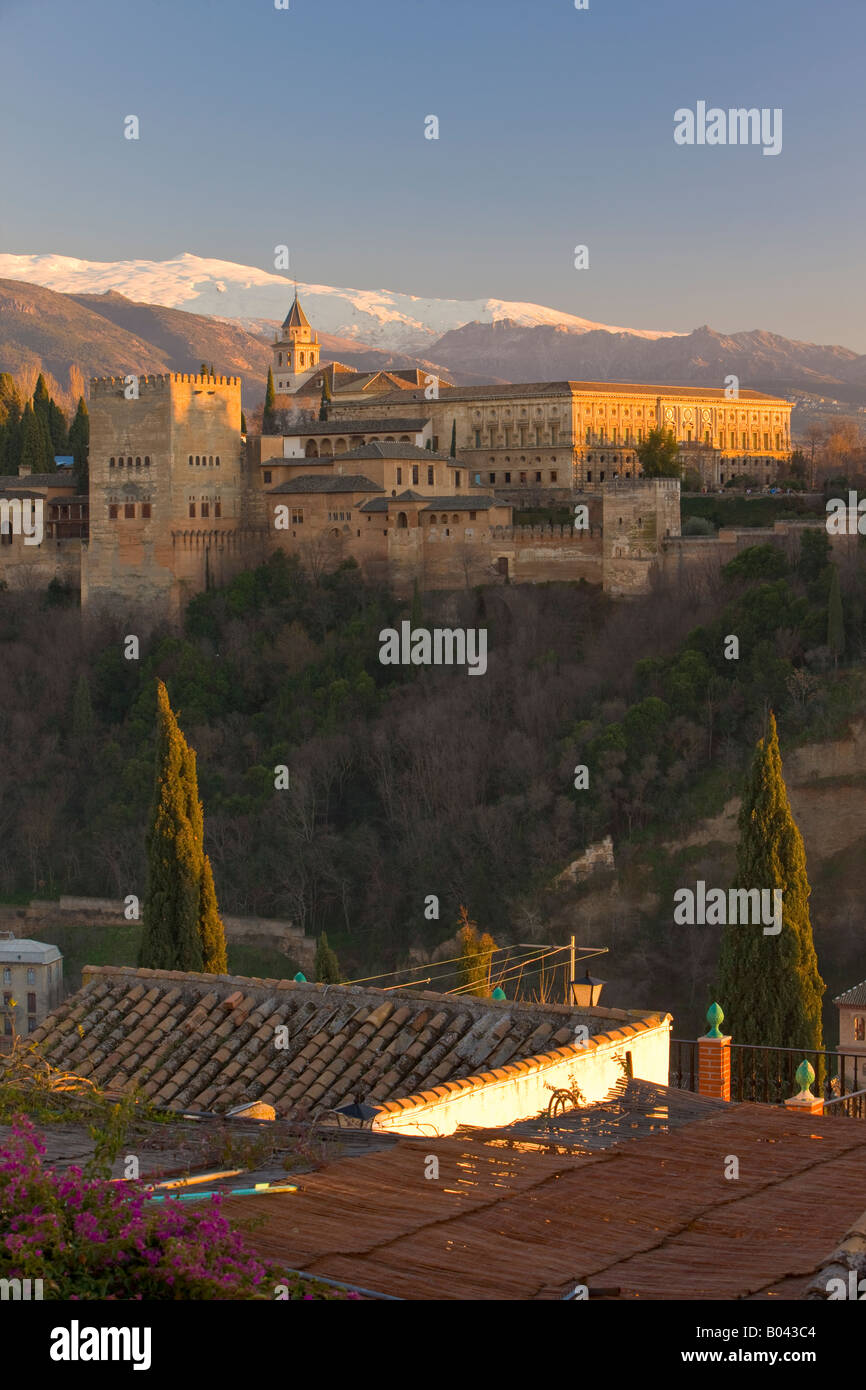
[222,1105,866,1301]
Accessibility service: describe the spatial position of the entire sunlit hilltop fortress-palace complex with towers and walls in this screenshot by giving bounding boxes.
[0,296,791,617]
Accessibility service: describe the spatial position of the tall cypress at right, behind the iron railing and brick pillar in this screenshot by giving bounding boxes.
[717,713,824,1051]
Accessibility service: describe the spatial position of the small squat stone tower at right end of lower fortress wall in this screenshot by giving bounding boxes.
[602,478,680,598]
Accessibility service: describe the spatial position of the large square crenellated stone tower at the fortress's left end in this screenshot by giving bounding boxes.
[82,373,264,617]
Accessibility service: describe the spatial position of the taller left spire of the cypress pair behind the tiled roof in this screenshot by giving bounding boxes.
[139,681,203,970]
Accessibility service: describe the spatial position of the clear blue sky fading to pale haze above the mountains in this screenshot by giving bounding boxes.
[0,0,866,353]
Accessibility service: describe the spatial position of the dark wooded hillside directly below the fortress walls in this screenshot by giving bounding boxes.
[0,531,866,1045]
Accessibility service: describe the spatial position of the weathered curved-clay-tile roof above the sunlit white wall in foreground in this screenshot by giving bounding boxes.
[32,966,660,1113]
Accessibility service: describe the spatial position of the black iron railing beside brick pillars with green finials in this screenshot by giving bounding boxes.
[669,1038,866,1118]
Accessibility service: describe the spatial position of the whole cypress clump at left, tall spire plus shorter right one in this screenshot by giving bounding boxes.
[139,681,228,974]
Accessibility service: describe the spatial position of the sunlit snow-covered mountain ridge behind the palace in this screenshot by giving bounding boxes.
[0,253,684,353]
